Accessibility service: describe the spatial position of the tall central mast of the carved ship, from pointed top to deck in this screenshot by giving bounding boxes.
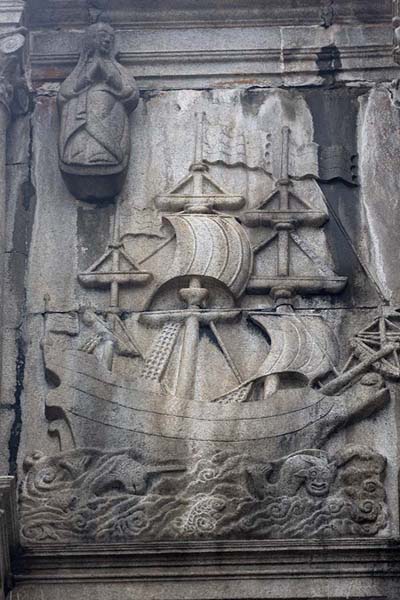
[145,113,251,400]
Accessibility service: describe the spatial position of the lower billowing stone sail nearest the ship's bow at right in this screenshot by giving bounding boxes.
[252,314,339,382]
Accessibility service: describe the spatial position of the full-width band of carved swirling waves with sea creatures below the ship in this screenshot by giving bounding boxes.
[21,446,388,543]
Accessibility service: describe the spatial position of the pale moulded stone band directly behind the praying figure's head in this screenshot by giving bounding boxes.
[30,24,396,89]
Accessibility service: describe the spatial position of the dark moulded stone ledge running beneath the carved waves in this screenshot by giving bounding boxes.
[13,539,400,600]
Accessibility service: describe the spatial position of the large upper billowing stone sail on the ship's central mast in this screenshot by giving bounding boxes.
[165,214,253,297]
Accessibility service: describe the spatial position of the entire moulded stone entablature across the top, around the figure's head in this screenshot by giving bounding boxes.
[26,0,396,89]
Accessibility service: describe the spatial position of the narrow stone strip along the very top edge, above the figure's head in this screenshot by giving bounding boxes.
[27,0,392,29]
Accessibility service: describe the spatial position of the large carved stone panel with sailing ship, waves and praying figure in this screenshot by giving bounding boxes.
[20,36,400,545]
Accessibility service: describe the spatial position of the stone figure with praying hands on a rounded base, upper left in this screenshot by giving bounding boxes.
[58,22,139,201]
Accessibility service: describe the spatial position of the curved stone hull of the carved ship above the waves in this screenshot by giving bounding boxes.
[46,344,386,458]
